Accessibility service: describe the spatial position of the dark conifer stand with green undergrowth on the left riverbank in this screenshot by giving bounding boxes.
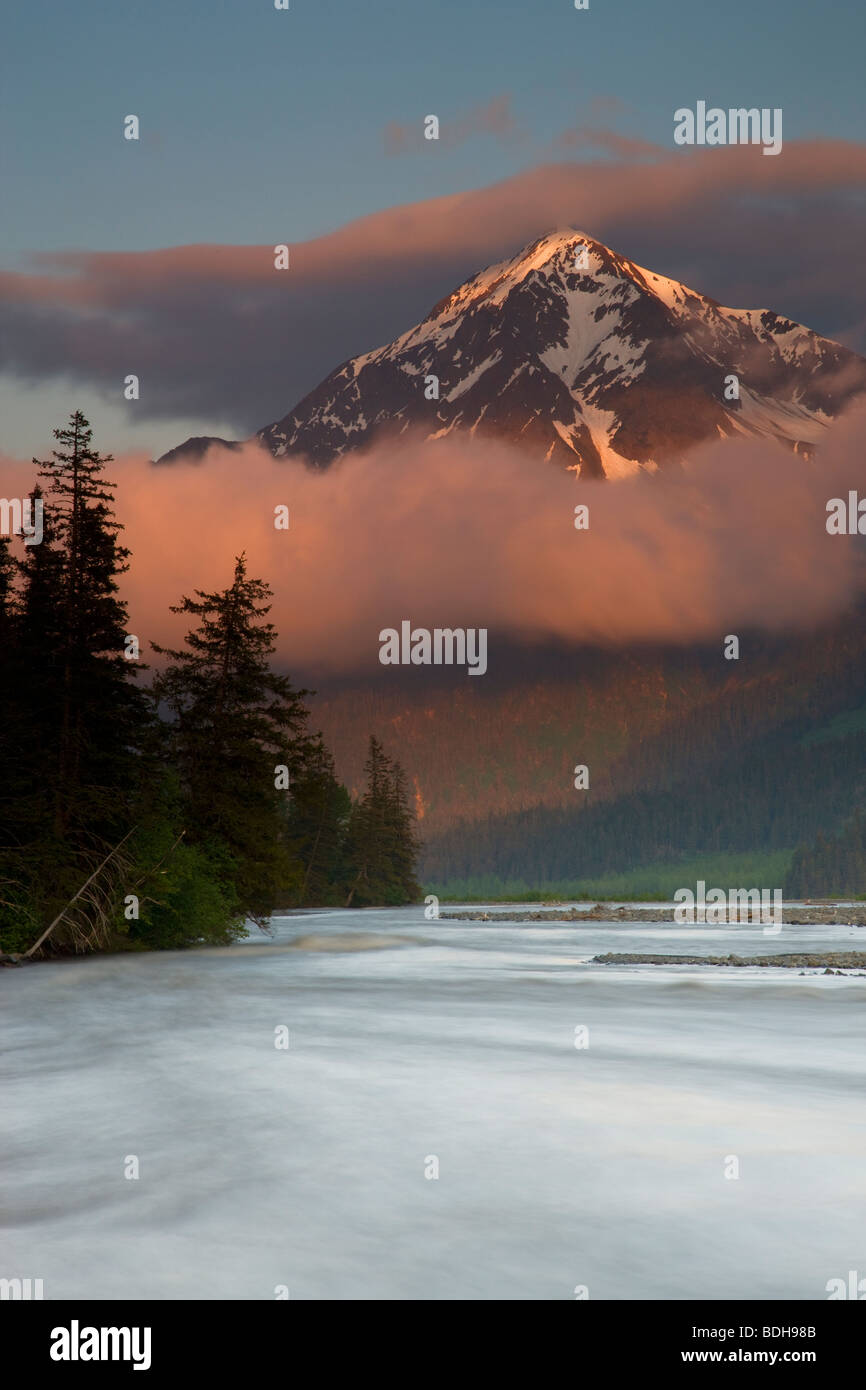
[0,411,420,954]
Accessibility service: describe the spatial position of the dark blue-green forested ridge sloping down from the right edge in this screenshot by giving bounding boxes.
[414,624,866,892]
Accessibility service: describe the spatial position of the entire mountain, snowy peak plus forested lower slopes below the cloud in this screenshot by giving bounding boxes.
[147,231,866,892]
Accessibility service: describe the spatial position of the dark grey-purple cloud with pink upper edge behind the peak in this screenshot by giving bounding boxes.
[0,132,866,436]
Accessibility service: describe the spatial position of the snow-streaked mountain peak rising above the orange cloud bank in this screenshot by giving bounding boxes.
[254,231,866,478]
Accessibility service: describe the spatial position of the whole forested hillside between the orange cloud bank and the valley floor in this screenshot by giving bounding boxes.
[316,616,866,892]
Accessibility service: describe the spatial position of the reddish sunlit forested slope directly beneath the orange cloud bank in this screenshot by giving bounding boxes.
[311,616,866,842]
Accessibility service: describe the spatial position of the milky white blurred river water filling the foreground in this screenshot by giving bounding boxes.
[0,908,866,1300]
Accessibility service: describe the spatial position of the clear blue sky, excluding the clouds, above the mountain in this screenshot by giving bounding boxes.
[0,0,866,450]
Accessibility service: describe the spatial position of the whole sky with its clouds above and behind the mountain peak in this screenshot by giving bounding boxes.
[0,0,866,457]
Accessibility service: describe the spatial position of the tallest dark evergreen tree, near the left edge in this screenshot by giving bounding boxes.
[0,411,149,949]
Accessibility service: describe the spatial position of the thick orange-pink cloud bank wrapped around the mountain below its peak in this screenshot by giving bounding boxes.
[0,410,866,680]
